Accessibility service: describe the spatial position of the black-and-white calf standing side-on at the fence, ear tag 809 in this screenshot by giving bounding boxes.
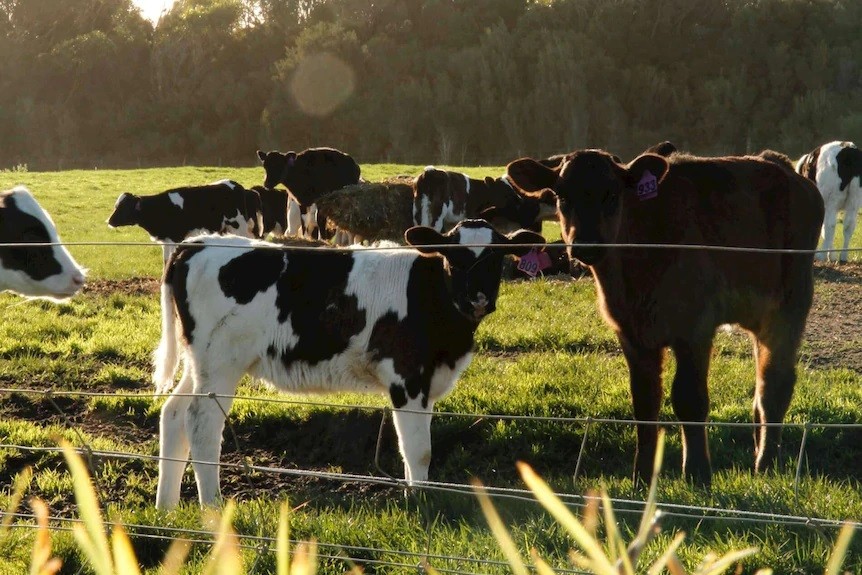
[154,220,543,509]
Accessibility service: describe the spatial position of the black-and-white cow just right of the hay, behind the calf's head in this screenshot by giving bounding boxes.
[413,166,556,232]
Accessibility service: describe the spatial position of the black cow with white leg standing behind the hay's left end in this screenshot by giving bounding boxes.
[257,148,361,238]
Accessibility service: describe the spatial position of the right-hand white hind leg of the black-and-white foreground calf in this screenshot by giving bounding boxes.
[186,367,242,505]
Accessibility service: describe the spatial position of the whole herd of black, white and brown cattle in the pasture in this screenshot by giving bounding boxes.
[0,142,862,508]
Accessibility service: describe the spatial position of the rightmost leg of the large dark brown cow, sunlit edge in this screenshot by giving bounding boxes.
[754,318,807,472]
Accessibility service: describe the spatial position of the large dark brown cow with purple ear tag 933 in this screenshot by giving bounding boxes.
[507,150,824,485]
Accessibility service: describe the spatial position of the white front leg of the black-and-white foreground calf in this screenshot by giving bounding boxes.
[392,394,434,485]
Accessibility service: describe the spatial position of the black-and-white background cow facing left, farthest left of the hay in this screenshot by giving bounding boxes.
[107,180,263,262]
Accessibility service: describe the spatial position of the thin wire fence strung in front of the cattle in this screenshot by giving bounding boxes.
[0,238,862,575]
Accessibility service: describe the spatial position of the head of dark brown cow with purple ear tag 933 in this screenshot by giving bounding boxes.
[506,150,669,265]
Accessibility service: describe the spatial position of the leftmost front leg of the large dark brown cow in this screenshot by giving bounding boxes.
[620,337,664,482]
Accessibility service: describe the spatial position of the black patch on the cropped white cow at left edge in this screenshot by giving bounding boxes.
[0,191,63,281]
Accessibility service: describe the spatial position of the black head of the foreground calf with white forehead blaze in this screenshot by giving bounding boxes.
[404,220,545,322]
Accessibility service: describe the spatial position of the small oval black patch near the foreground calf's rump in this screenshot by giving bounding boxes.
[218,249,285,304]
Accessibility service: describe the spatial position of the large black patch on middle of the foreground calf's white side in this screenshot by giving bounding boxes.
[275,251,366,366]
